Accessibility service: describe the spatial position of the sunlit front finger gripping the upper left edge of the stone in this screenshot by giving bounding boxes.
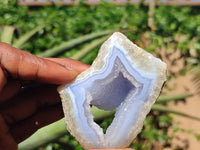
[0,43,78,84]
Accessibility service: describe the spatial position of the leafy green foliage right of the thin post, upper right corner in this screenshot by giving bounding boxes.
[152,6,200,53]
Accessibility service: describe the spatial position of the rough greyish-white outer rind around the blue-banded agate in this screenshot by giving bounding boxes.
[58,32,166,149]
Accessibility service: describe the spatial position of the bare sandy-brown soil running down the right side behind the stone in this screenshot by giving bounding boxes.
[152,38,200,150]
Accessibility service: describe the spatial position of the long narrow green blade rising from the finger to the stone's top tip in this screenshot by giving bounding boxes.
[37,30,113,57]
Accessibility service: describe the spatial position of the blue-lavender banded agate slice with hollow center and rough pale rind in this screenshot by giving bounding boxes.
[58,32,166,149]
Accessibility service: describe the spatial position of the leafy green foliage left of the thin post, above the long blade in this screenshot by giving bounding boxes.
[0,3,147,54]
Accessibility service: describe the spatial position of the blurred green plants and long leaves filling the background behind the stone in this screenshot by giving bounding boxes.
[0,0,200,150]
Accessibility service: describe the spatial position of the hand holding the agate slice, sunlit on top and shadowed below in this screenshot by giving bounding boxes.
[0,43,89,150]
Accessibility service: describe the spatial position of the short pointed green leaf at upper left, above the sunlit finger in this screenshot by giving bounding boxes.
[13,24,46,48]
